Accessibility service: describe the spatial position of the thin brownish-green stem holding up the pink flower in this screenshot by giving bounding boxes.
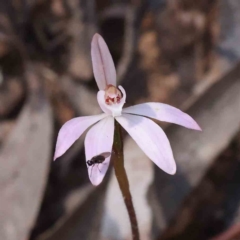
[113,121,140,240]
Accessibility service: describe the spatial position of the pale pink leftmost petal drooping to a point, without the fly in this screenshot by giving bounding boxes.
[54,114,107,160]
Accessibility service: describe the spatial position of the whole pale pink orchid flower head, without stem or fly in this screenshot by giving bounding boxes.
[54,34,201,185]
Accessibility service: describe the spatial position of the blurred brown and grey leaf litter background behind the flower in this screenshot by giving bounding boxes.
[0,0,240,240]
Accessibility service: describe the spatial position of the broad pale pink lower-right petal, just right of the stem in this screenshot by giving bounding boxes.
[116,114,176,174]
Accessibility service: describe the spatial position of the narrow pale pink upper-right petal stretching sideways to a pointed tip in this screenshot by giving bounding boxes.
[123,102,201,131]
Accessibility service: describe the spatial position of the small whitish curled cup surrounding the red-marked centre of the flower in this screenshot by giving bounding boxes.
[97,86,126,117]
